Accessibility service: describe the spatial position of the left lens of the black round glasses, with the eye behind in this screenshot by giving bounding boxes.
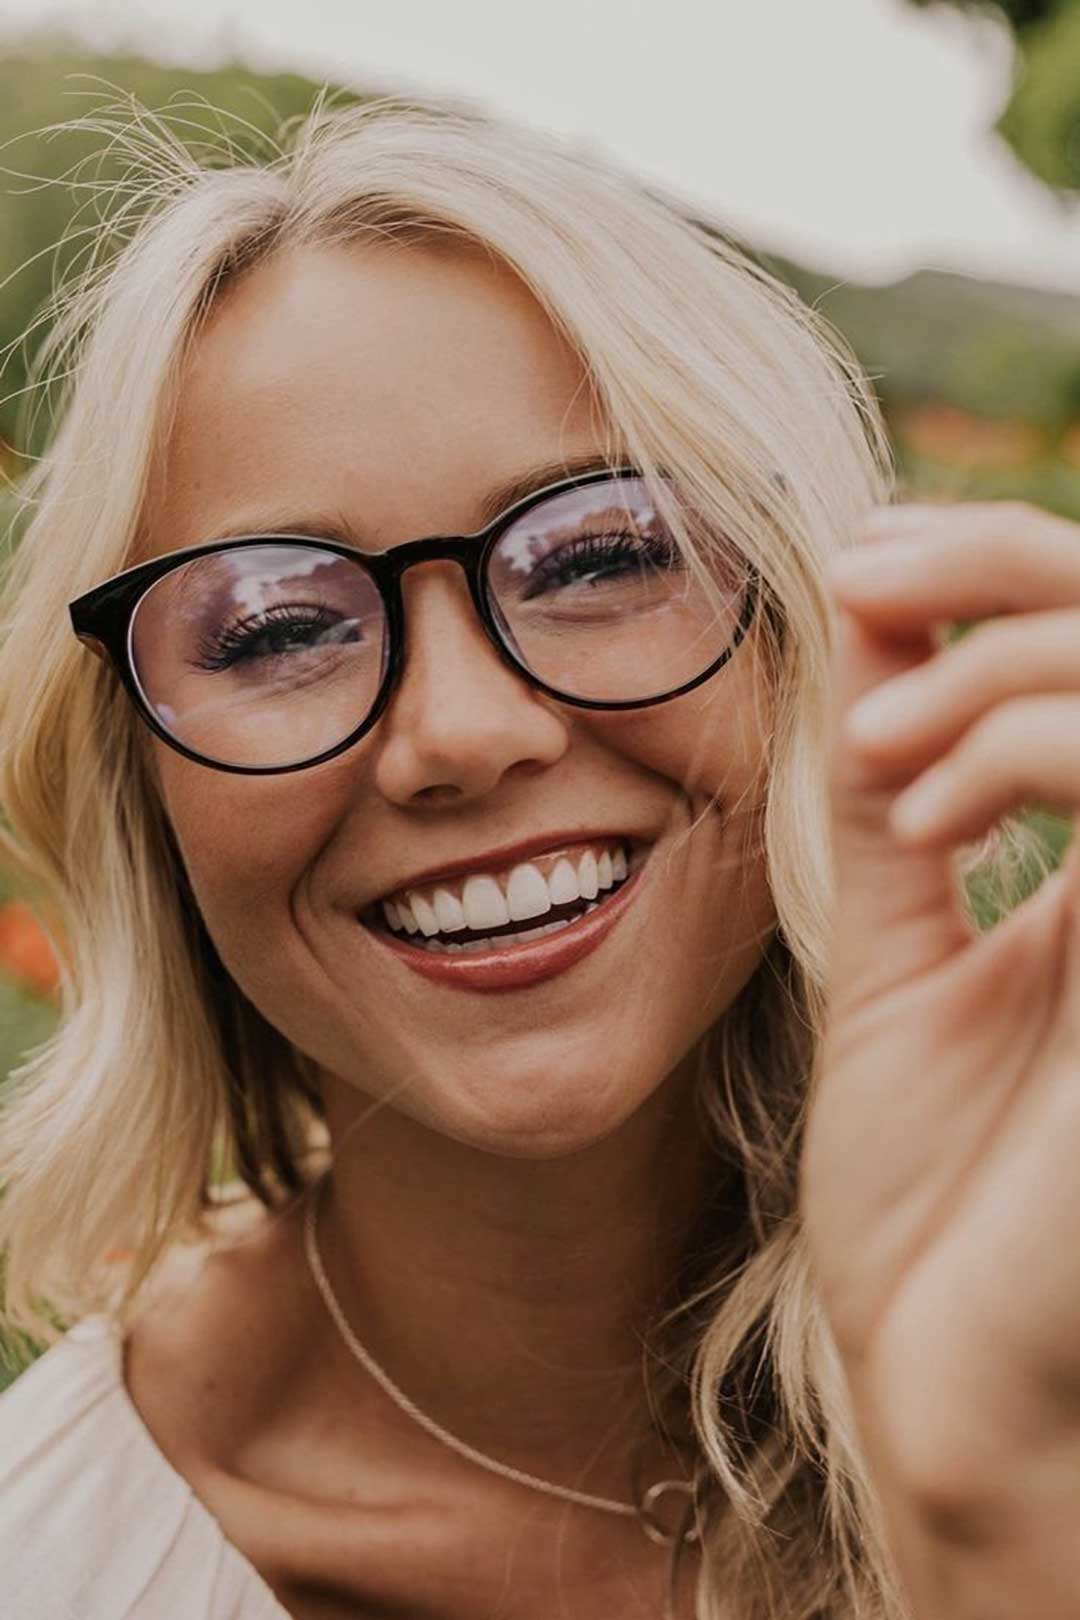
[131,541,387,766]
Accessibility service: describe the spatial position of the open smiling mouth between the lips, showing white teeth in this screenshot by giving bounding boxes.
[361,839,651,956]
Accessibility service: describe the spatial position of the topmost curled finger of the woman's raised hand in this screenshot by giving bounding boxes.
[829,501,1080,635]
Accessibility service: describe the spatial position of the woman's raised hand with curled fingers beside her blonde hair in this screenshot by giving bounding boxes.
[801,502,1080,1509]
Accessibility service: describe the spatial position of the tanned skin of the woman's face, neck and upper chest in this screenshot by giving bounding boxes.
[126,248,776,1620]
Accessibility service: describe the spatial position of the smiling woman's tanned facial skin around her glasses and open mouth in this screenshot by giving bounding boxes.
[147,236,786,1157]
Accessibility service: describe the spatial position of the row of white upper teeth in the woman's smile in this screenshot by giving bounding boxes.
[382,846,630,938]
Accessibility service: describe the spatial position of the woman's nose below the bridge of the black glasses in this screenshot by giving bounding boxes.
[376,561,570,807]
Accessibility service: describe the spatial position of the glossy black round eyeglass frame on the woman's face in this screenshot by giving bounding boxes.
[68,467,759,776]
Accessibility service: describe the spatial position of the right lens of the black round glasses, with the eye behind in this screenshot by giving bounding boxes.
[487,478,746,703]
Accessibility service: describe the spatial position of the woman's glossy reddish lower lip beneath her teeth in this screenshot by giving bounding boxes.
[361,851,644,991]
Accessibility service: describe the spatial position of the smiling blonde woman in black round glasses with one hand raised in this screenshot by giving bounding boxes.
[0,91,1080,1620]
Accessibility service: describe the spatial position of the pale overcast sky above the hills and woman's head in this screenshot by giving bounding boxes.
[0,0,1080,292]
